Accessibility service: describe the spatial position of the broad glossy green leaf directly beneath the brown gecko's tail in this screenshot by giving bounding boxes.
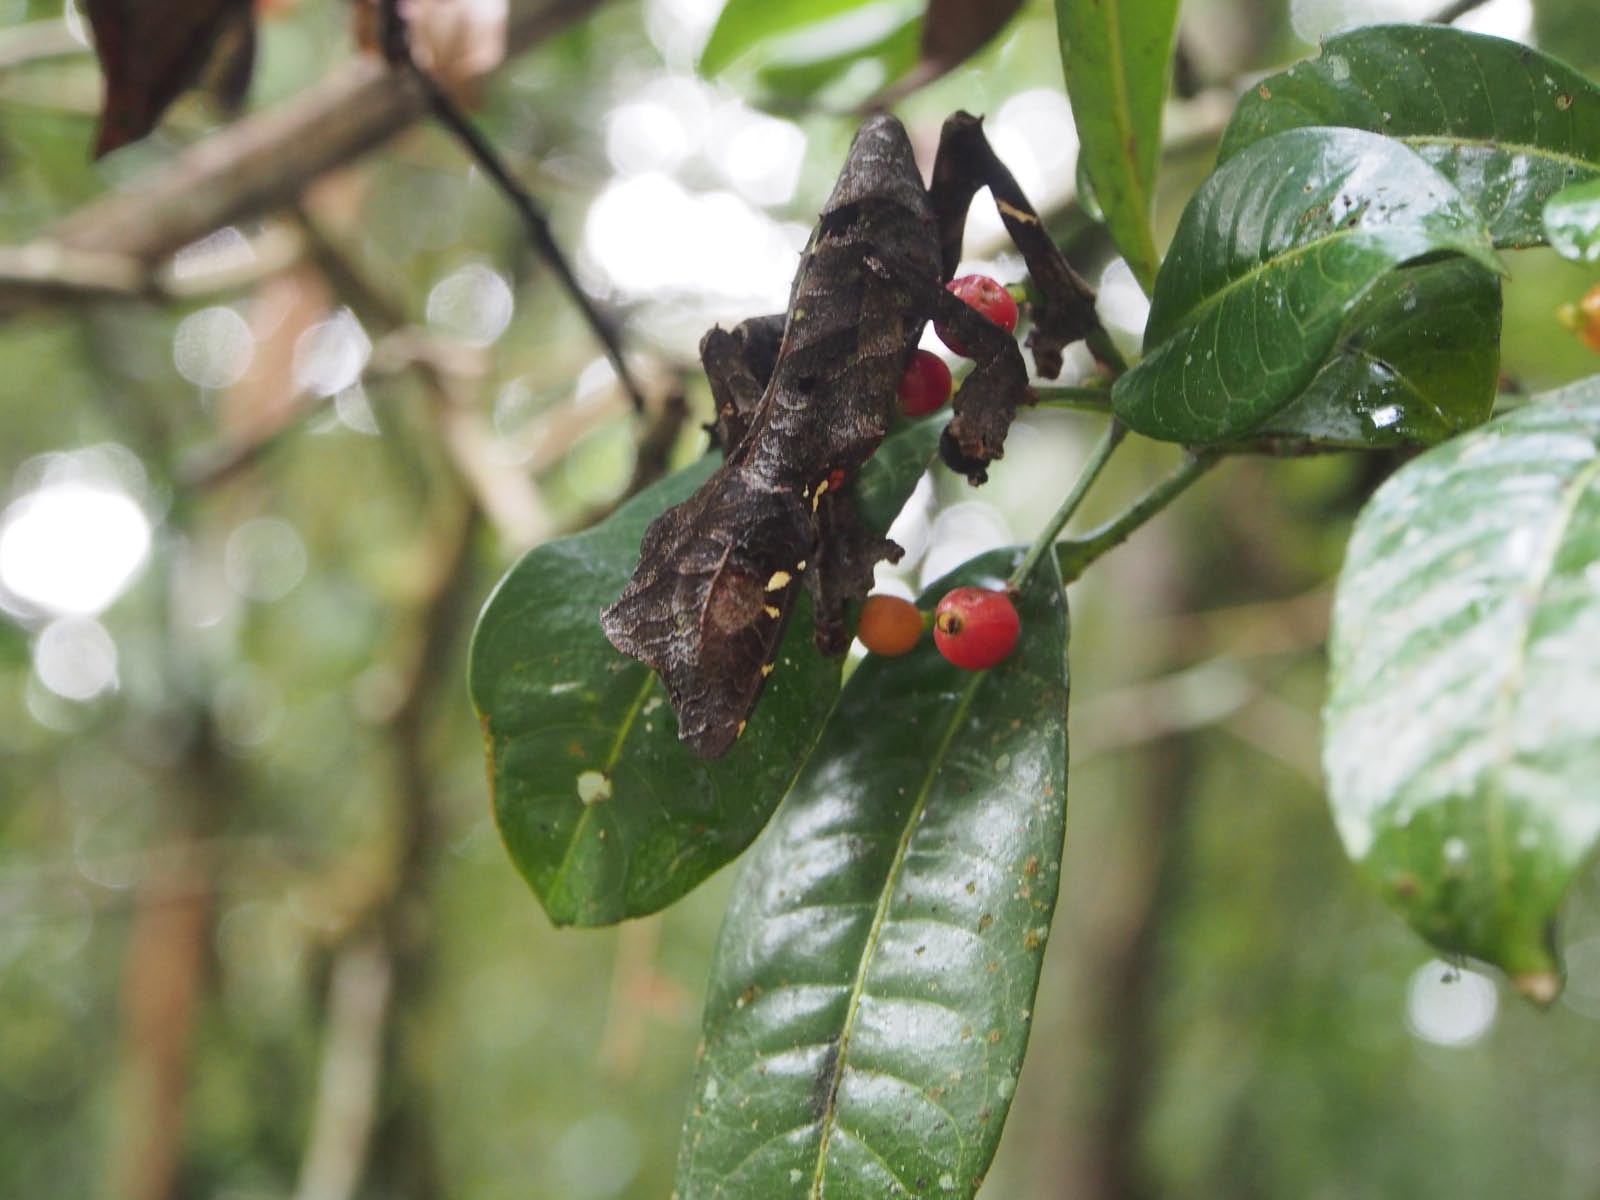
[470,426,938,925]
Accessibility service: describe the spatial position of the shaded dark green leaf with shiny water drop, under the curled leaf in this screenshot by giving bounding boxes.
[1254,258,1501,448]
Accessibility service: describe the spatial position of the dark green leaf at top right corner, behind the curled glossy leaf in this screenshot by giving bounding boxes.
[1219,26,1600,246]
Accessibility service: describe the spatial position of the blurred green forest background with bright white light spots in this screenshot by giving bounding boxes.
[0,0,1600,1200]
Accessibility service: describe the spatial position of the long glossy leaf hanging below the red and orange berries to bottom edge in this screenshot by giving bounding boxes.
[677,550,1067,1200]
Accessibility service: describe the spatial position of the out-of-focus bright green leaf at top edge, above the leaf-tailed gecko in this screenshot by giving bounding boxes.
[699,0,922,77]
